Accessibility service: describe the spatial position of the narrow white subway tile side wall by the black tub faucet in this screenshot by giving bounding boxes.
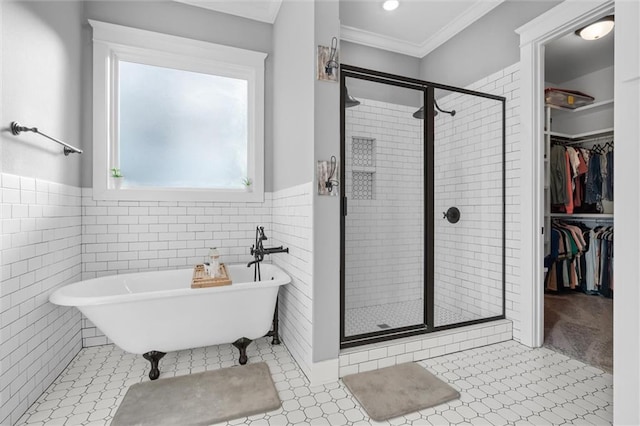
[269,182,313,377]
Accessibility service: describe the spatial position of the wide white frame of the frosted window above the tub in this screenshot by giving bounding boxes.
[89,20,267,202]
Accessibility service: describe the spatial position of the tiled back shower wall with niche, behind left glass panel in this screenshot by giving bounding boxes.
[345,99,424,309]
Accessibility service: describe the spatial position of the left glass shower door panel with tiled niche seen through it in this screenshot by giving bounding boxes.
[342,72,426,341]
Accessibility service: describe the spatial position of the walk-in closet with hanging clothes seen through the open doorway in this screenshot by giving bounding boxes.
[544,21,612,371]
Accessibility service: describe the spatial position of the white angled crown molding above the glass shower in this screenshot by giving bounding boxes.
[340,0,505,58]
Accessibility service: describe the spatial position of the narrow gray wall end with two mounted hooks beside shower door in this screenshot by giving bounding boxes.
[309,1,342,362]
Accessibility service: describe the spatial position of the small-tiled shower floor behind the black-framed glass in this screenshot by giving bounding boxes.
[345,299,471,336]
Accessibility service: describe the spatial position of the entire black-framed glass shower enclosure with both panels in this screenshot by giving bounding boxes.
[340,65,506,348]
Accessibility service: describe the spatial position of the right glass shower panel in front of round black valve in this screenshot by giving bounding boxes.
[433,90,505,329]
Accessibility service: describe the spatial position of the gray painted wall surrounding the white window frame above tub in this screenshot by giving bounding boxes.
[81,1,273,191]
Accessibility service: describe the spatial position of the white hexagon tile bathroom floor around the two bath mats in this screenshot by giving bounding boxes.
[18,338,613,426]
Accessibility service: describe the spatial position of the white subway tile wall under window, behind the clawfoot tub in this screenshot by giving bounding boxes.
[82,188,271,347]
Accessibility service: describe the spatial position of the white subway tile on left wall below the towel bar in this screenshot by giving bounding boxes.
[0,174,82,425]
